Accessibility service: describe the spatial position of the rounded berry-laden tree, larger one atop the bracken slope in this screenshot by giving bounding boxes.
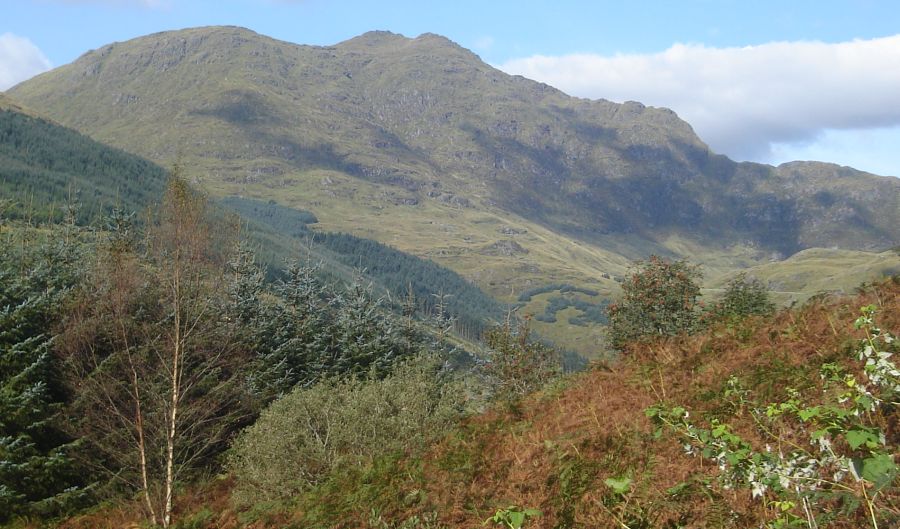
[607,255,701,348]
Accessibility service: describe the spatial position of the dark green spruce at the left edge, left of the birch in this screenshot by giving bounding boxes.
[0,229,83,523]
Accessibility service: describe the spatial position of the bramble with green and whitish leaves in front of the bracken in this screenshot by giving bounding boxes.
[646,305,900,529]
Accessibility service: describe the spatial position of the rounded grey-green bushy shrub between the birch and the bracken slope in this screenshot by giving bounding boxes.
[228,357,464,504]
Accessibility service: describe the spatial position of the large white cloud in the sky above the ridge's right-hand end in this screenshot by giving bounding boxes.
[499,35,900,161]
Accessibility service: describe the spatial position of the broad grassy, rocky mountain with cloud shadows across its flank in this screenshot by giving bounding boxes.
[9,27,900,352]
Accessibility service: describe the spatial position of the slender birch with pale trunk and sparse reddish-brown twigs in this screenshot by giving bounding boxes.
[63,176,243,528]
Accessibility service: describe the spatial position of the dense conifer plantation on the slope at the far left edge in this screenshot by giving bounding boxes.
[0,110,166,223]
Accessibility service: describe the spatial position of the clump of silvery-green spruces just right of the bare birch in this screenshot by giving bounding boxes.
[226,248,426,403]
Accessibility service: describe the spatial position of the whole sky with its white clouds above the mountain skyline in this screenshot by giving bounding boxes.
[0,0,900,175]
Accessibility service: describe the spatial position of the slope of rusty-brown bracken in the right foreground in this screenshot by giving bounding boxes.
[47,280,900,529]
